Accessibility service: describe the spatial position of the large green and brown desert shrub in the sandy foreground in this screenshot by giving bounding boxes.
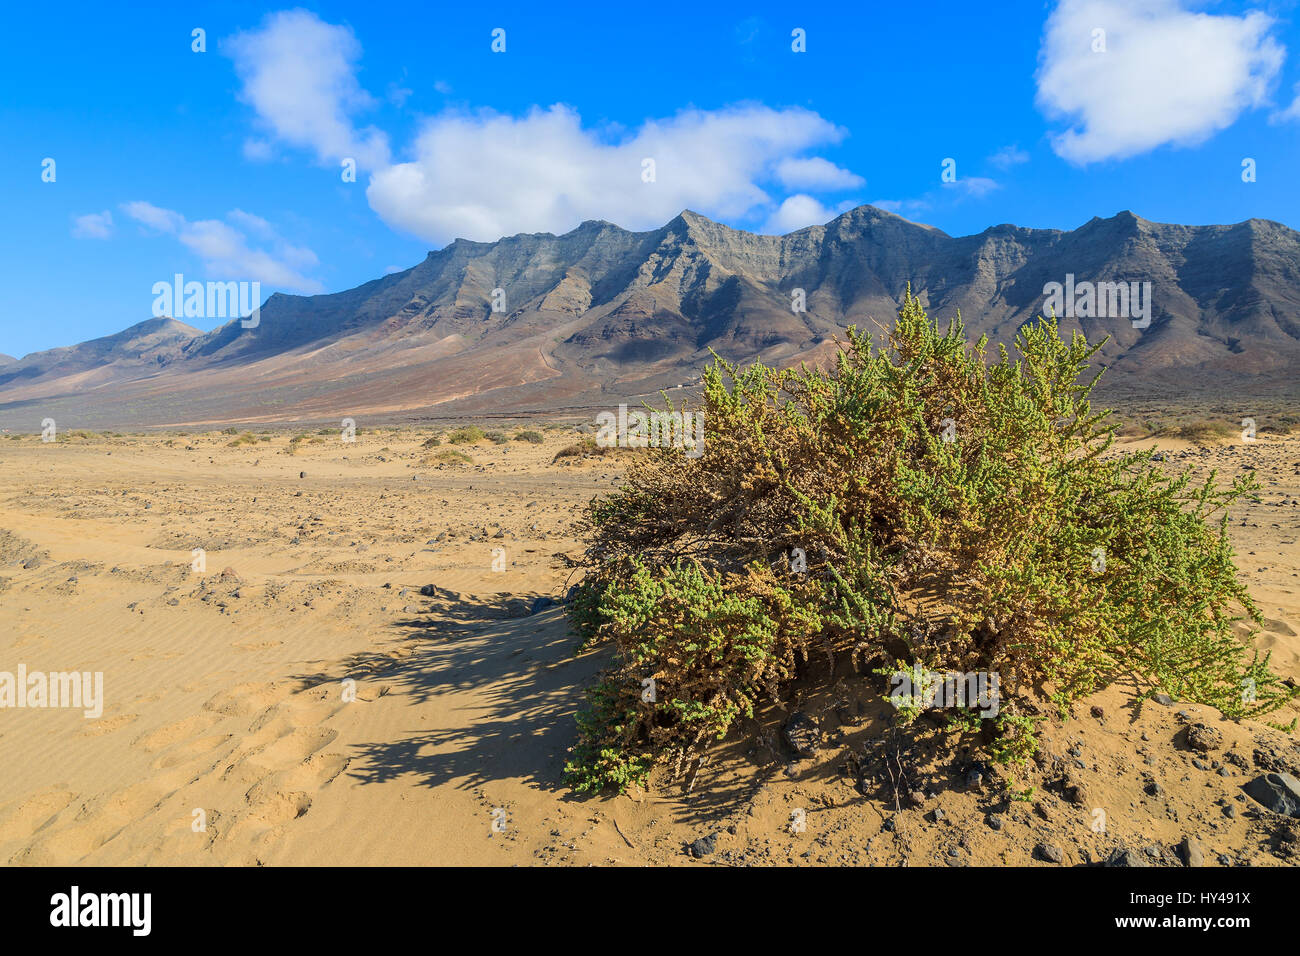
[567,293,1292,790]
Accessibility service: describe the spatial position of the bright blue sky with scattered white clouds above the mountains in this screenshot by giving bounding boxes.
[0,0,1300,356]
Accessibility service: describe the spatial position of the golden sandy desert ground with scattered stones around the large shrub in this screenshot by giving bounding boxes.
[0,429,1300,865]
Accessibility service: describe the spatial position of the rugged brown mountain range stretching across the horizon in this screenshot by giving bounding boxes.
[0,206,1300,427]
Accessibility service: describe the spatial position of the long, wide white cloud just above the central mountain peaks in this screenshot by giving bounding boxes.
[367,104,844,242]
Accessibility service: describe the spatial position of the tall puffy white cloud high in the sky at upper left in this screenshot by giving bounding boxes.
[225,10,389,169]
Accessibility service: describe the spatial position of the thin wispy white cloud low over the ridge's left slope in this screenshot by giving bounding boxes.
[121,200,324,293]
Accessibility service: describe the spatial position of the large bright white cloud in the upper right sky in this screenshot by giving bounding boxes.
[1037,0,1286,164]
